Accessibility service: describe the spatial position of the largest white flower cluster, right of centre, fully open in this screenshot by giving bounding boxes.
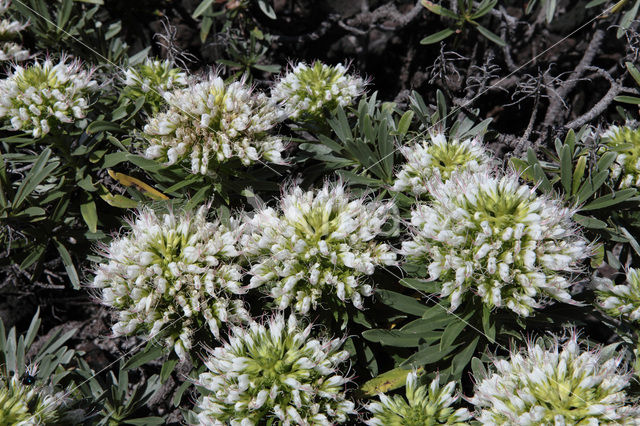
[402,173,592,316]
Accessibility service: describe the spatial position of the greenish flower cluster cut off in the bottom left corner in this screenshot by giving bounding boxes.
[0,374,67,426]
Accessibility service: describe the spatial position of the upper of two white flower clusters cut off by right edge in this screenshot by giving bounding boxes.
[601,126,640,188]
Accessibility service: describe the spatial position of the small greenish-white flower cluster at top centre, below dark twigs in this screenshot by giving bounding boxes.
[271,62,365,120]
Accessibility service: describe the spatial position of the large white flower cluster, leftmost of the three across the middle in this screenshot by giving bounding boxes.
[93,206,250,359]
